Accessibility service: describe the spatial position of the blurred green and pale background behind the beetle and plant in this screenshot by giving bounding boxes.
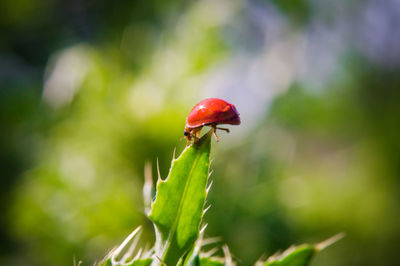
[0,0,400,266]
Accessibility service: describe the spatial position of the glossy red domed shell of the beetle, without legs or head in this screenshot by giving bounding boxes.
[186,98,240,128]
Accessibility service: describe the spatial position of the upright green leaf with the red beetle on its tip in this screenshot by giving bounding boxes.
[149,131,211,265]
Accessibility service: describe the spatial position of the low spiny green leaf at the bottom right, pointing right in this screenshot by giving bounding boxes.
[256,233,344,266]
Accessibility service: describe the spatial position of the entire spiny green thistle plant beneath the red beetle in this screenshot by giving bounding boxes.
[98,131,342,266]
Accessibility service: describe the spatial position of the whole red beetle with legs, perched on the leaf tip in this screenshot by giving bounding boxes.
[183,98,240,144]
